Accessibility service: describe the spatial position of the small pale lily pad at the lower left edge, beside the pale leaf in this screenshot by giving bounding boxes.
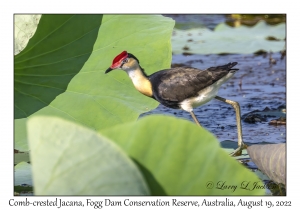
[14,162,32,186]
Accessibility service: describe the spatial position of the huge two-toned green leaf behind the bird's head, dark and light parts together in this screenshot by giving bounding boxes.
[14,15,174,149]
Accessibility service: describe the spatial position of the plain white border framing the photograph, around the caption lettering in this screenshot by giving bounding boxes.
[0,0,300,209]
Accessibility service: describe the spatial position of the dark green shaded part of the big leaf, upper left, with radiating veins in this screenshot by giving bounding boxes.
[14,15,102,119]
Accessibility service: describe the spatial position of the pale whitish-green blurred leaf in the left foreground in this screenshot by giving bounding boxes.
[28,116,149,195]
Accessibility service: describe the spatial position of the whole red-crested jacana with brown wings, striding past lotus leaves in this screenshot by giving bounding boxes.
[105,51,246,156]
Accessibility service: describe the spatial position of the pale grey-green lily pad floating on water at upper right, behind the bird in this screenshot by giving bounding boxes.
[172,21,286,54]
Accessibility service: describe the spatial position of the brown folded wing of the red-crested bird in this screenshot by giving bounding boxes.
[149,63,237,108]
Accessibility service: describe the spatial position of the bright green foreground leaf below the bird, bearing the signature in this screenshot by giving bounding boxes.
[101,116,264,195]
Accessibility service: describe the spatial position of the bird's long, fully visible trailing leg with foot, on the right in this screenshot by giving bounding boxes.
[215,96,247,156]
